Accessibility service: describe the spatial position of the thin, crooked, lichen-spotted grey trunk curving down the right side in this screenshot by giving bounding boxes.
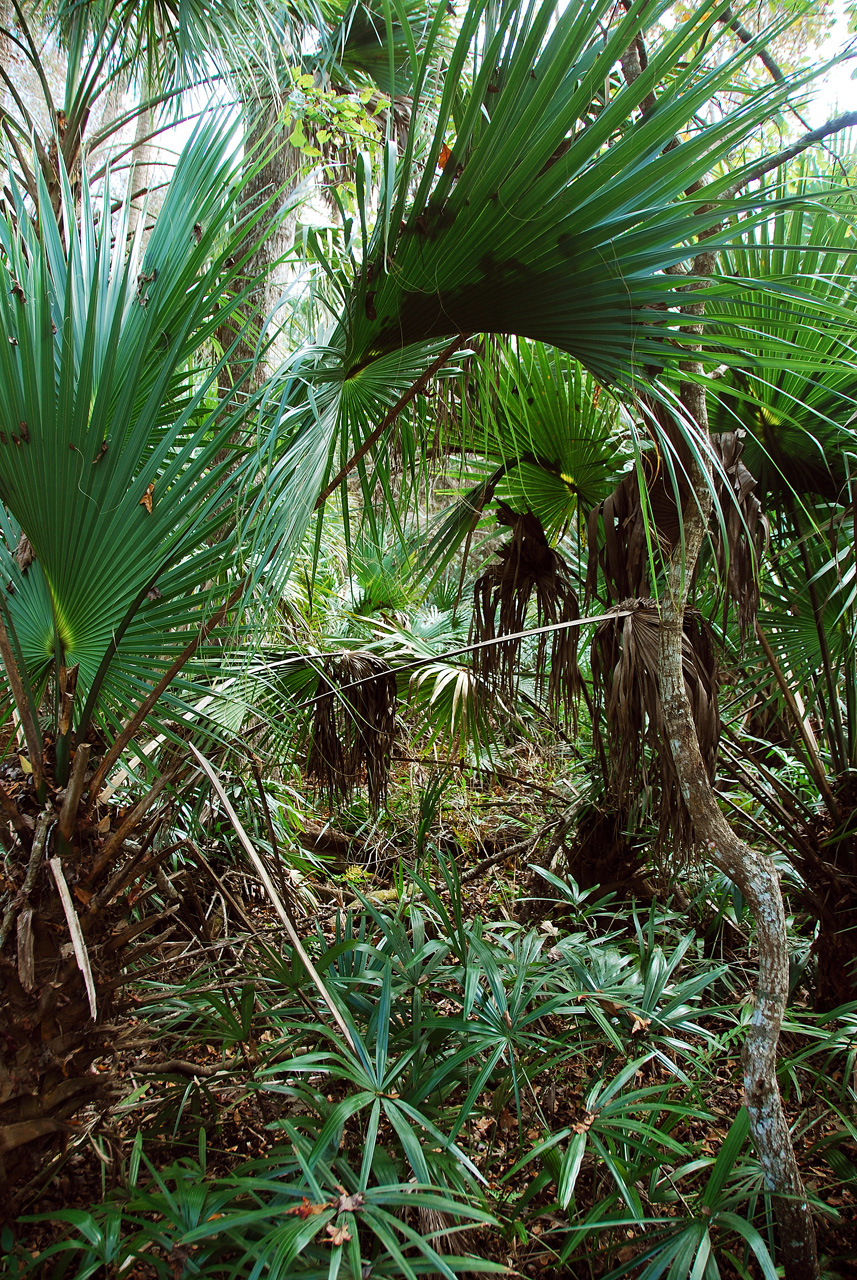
[659,365,819,1280]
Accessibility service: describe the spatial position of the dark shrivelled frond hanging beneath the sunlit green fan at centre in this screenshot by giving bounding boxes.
[471,503,581,716]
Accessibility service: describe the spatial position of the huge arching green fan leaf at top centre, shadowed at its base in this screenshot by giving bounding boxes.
[336,0,803,383]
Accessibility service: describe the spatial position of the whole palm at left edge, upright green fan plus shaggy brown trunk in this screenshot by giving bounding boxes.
[0,122,318,1172]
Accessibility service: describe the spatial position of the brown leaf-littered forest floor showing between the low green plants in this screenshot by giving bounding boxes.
[0,762,857,1280]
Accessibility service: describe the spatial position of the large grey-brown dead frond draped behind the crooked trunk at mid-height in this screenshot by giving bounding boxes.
[591,599,720,850]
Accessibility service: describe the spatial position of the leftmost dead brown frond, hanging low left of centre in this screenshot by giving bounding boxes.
[307,653,397,808]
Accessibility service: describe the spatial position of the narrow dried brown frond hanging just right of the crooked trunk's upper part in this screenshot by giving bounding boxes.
[711,430,770,639]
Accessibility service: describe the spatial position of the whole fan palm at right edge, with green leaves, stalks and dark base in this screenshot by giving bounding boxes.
[709,189,857,1007]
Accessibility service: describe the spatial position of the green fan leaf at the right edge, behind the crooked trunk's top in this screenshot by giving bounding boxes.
[707,180,857,498]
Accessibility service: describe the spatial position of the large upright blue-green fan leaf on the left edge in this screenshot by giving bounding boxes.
[0,120,289,752]
